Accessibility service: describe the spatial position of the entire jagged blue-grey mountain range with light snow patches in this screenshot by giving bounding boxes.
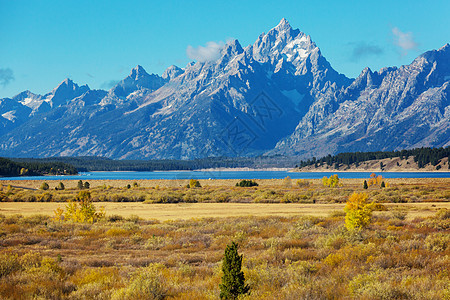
[0,19,450,159]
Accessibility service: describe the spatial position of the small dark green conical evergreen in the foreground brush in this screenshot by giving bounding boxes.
[220,242,250,299]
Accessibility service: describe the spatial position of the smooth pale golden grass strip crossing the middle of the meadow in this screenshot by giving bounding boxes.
[0,202,450,221]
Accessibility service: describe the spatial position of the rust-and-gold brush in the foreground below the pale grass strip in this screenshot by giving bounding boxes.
[0,203,450,299]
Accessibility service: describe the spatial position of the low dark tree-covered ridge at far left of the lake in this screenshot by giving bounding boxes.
[0,157,78,176]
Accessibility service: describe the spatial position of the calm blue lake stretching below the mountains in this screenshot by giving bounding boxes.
[0,171,450,180]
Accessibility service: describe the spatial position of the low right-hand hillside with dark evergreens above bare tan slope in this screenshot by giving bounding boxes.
[296,147,450,172]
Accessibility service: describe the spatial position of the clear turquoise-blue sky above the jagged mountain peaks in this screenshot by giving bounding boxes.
[0,0,450,98]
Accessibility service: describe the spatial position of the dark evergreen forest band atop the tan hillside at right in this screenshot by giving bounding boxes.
[299,147,450,168]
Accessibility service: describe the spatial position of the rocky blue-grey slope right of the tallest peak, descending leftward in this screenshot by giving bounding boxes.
[275,44,450,156]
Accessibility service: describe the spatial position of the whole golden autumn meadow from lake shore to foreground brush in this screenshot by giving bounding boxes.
[0,179,450,299]
